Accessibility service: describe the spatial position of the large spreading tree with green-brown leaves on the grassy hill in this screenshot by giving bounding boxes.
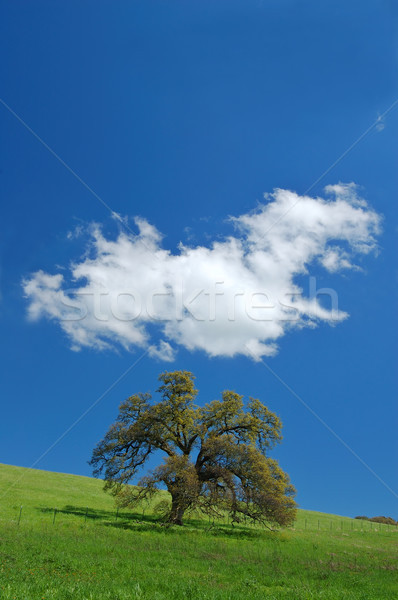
[90,371,296,525]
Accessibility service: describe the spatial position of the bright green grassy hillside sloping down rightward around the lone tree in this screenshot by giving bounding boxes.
[0,465,398,600]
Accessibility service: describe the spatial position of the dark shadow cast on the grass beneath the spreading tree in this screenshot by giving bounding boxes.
[37,505,270,538]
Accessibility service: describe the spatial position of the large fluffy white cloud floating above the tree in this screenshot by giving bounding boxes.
[23,184,381,361]
